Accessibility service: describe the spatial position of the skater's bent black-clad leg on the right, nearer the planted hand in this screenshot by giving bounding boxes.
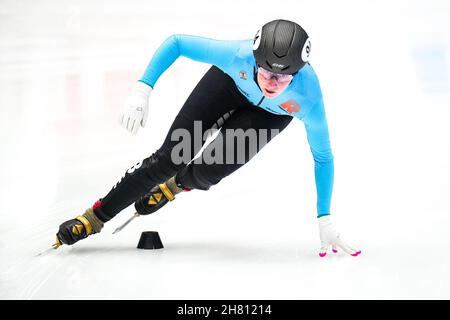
[176,107,292,190]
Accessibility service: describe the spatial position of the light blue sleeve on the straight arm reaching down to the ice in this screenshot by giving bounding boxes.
[303,99,334,217]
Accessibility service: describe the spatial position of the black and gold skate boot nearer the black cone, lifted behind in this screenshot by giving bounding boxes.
[134,177,190,215]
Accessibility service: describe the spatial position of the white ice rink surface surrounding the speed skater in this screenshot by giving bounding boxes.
[0,0,450,299]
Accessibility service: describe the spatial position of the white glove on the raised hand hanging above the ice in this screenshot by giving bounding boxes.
[119,81,153,134]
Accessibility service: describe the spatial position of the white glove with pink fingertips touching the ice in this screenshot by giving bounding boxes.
[319,215,361,257]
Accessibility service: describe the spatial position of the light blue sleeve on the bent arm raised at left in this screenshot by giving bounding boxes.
[140,34,241,88]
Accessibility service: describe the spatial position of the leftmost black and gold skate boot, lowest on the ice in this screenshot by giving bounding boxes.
[56,208,103,245]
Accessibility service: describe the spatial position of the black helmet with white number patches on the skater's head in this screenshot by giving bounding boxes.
[253,19,311,74]
